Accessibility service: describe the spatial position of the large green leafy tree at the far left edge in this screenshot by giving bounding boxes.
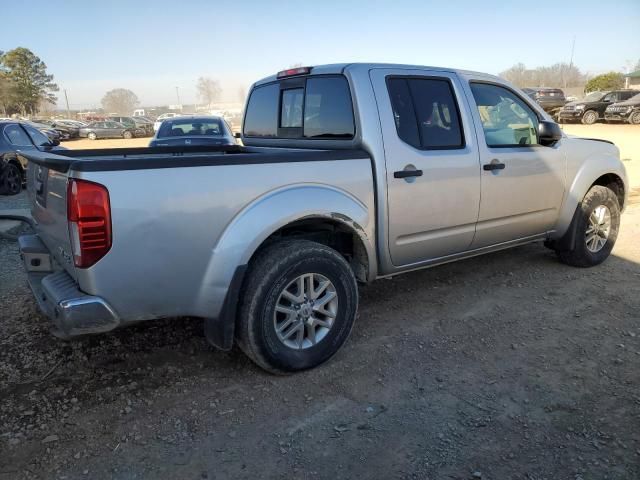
[0,47,58,114]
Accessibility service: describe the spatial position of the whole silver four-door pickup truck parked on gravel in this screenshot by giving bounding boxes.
[20,64,628,373]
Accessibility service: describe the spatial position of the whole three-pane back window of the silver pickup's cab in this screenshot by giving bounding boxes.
[244,75,355,139]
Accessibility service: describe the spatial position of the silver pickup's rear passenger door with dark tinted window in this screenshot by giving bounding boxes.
[370,69,480,266]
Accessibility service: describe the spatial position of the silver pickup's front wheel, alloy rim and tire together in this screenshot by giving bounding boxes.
[558,185,620,267]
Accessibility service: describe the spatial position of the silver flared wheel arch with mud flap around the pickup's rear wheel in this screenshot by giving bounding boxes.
[196,184,376,349]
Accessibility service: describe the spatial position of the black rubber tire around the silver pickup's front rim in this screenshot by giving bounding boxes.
[557,185,620,268]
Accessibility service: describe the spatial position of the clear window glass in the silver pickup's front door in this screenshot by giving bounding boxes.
[471,83,539,147]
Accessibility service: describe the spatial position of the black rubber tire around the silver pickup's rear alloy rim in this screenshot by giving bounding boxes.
[236,240,358,374]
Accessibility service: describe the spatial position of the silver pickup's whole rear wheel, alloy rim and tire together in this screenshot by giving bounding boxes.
[236,240,358,373]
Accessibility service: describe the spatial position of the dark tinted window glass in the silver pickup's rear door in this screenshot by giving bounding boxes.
[387,78,465,150]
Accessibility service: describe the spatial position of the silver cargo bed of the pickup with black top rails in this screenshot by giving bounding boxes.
[24,146,375,333]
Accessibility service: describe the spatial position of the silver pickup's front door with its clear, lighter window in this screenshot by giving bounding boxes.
[469,81,566,248]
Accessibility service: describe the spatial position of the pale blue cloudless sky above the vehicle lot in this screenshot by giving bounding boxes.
[0,0,640,109]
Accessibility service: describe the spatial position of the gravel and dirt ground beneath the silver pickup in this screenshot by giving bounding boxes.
[0,125,640,480]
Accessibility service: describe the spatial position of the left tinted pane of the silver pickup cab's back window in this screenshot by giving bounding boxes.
[244,83,280,137]
